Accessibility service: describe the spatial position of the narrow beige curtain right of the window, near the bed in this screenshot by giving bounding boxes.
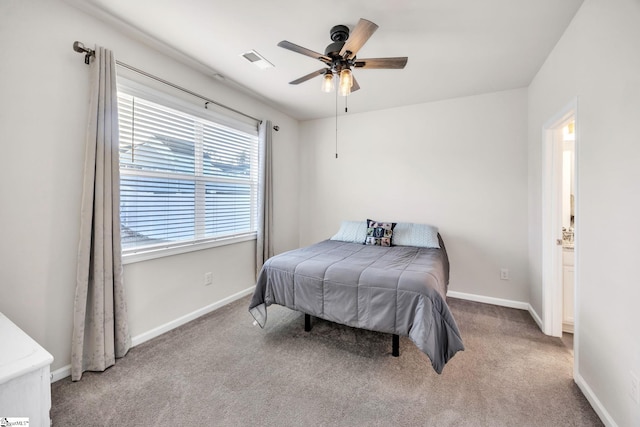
[256,120,273,277]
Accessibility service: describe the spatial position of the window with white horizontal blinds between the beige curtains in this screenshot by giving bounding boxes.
[118,87,258,255]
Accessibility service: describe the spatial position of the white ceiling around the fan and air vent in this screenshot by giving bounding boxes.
[72,0,583,120]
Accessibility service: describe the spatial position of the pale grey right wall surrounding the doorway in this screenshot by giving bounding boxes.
[528,0,640,426]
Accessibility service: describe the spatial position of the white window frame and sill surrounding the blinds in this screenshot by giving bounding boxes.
[118,75,260,264]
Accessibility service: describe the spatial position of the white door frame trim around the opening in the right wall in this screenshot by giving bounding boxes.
[542,98,579,340]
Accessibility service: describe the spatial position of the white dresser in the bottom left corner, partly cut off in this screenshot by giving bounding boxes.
[0,313,53,427]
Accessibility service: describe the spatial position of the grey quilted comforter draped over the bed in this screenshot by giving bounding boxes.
[249,240,464,373]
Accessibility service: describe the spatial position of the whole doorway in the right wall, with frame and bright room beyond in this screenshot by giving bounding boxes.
[542,100,578,342]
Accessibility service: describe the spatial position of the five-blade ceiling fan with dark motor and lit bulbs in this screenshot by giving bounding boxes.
[278,18,408,96]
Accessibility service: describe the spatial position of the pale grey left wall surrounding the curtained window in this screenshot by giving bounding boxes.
[0,0,298,370]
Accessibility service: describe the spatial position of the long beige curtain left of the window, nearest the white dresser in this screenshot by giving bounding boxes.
[71,47,131,381]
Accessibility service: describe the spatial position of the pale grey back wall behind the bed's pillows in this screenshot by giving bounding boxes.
[300,89,529,305]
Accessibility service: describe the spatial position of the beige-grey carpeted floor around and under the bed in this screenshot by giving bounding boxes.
[51,297,602,427]
